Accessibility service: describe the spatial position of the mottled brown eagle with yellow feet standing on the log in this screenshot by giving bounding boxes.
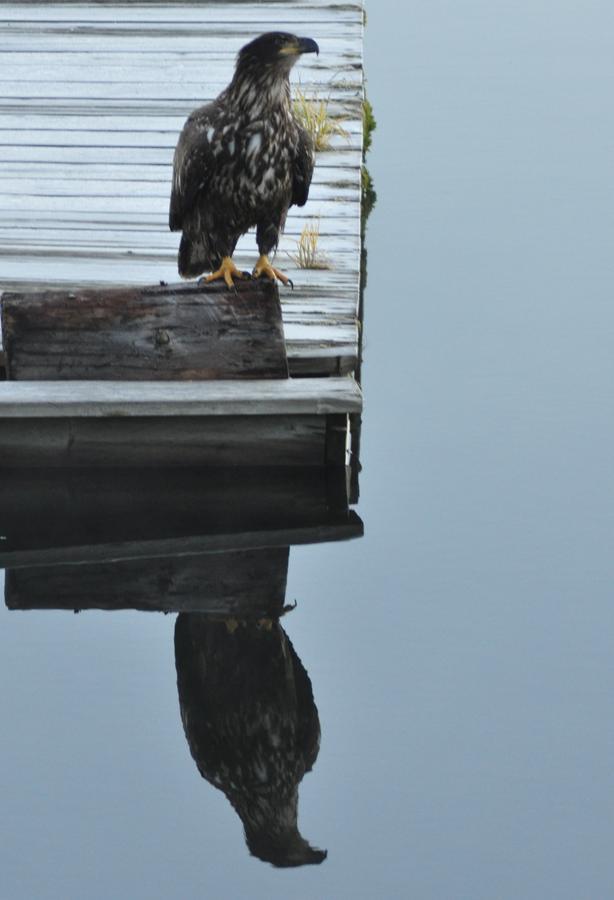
[169,31,318,287]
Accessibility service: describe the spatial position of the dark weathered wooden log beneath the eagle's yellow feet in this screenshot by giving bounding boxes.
[2,280,288,381]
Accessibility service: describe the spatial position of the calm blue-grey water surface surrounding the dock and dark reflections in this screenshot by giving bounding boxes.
[0,0,614,900]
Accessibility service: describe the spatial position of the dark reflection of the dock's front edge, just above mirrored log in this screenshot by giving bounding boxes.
[0,468,362,568]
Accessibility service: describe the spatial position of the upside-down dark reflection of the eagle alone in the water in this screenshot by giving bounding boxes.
[175,613,326,867]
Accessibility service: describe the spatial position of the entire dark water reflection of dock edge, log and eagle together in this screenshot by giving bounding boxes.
[0,469,362,867]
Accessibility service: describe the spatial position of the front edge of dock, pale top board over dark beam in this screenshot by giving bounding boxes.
[0,378,362,466]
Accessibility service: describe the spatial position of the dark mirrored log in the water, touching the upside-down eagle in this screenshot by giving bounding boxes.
[5,547,289,616]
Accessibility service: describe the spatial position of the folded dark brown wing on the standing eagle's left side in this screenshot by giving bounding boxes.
[168,104,215,231]
